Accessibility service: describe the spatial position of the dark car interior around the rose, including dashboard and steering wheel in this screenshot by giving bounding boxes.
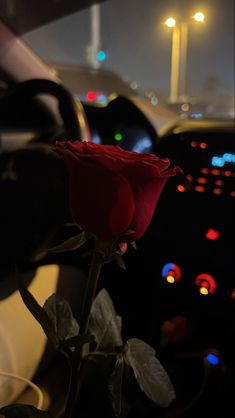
[0,1,235,418]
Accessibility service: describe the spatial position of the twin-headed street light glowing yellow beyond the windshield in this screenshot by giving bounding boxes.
[165,11,205,103]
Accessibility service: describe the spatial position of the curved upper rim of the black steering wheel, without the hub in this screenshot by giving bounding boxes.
[1,78,89,141]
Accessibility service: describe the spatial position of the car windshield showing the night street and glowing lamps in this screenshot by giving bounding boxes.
[5,0,234,119]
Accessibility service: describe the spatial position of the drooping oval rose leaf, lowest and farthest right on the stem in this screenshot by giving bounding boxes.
[125,338,175,408]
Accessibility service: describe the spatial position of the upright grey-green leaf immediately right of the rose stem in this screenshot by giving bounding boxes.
[89,289,123,350]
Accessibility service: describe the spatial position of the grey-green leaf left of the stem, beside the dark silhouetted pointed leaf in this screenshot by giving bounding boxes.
[43,293,79,343]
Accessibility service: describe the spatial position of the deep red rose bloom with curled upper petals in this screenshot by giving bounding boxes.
[54,141,181,242]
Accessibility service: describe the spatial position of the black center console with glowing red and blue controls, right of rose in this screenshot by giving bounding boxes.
[87,111,235,417]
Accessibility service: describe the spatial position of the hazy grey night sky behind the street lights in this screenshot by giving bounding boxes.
[24,0,234,95]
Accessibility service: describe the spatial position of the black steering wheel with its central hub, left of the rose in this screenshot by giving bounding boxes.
[0,79,92,274]
